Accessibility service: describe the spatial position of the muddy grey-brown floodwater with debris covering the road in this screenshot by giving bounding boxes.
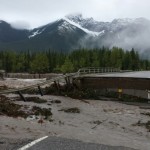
[0,79,150,150]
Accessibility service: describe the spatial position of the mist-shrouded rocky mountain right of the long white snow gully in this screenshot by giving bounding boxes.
[64,14,150,54]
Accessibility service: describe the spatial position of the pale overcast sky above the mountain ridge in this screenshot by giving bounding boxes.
[0,0,150,28]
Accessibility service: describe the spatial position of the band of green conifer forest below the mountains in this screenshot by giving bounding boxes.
[0,47,150,73]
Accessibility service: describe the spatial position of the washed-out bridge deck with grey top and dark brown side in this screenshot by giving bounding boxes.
[75,71,150,90]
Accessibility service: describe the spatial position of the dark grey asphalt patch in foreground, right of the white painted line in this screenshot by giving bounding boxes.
[28,137,137,150]
